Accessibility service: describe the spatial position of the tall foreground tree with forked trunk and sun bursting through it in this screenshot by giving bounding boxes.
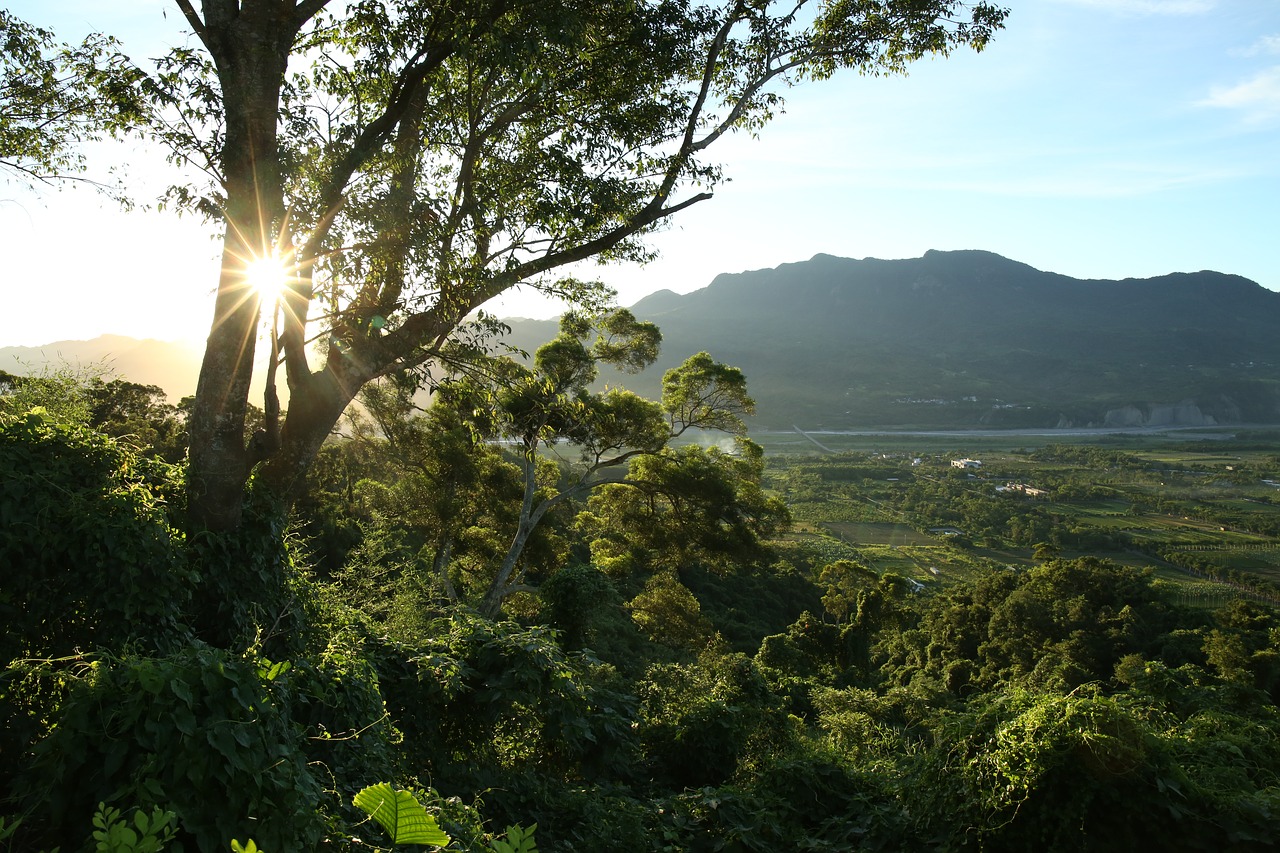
[142,0,1006,530]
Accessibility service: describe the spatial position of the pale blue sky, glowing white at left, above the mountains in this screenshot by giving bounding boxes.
[0,0,1280,346]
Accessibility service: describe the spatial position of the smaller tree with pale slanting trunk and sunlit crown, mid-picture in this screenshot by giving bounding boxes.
[364,309,754,617]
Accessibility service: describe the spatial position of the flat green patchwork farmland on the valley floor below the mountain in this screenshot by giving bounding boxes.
[756,430,1280,602]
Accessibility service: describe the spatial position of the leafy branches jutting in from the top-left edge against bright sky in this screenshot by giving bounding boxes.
[0,9,154,186]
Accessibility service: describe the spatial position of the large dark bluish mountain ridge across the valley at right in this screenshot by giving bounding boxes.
[513,251,1280,429]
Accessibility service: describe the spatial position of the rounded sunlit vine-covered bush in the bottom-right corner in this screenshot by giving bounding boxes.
[911,689,1275,850]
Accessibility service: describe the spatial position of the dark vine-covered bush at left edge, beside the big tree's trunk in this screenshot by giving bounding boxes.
[0,409,195,663]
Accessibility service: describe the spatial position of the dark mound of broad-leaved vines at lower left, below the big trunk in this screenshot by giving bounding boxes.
[24,646,321,849]
